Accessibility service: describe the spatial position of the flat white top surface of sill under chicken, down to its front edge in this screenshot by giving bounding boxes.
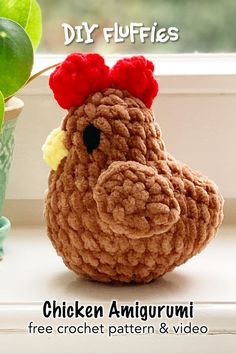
[0,225,236,302]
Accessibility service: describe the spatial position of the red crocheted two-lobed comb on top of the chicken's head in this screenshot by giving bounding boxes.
[49,53,158,109]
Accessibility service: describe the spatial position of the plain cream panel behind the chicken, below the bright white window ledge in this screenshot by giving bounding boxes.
[7,71,236,199]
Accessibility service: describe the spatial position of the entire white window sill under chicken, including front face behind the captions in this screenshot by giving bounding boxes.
[0,227,236,354]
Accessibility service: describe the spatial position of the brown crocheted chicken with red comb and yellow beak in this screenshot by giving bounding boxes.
[43,53,223,283]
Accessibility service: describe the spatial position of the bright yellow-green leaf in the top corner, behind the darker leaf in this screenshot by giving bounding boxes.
[0,0,42,49]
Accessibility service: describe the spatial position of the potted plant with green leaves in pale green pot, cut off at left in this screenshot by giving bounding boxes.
[0,0,42,259]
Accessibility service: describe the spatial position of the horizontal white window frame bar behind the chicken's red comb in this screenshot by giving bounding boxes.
[21,53,236,95]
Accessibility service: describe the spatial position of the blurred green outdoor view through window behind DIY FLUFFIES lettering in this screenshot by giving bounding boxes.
[39,0,236,54]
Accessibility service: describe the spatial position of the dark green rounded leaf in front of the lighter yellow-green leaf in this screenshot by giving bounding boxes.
[0,18,33,98]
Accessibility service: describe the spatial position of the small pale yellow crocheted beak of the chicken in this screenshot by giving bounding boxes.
[42,128,69,171]
